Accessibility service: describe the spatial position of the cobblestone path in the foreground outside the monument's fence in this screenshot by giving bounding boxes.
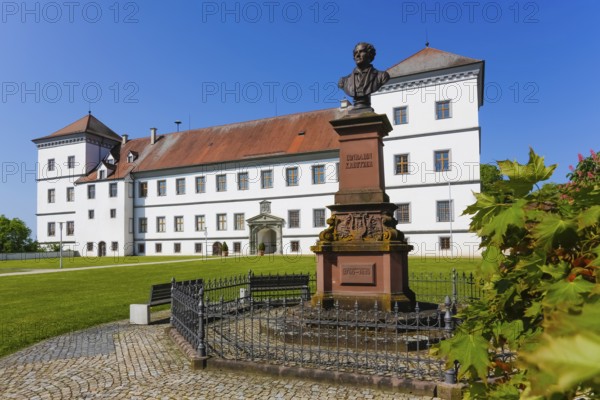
[0,316,440,400]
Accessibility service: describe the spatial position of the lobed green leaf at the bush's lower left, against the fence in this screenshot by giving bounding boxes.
[440,332,491,379]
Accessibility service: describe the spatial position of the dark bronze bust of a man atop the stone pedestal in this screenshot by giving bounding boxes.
[338,42,390,112]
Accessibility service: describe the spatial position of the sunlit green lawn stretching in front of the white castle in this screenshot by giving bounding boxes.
[0,256,476,357]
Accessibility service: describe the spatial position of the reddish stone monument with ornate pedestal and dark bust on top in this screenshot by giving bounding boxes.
[311,43,415,311]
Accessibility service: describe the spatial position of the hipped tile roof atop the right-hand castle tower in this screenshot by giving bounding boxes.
[387,47,482,78]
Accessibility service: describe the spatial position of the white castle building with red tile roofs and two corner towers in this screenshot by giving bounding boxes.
[33,47,484,256]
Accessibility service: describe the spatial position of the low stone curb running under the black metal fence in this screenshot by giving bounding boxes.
[166,326,463,400]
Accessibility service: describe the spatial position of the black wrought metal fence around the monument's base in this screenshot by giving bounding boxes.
[171,271,481,381]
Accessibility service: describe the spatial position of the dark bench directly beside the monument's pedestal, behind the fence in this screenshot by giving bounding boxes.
[249,274,310,301]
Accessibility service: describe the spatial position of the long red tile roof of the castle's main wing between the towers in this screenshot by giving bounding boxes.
[78,108,342,183]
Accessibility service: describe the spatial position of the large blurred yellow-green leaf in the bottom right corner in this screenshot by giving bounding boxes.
[521,332,600,395]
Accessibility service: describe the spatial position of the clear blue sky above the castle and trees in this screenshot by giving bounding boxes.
[0,0,600,232]
